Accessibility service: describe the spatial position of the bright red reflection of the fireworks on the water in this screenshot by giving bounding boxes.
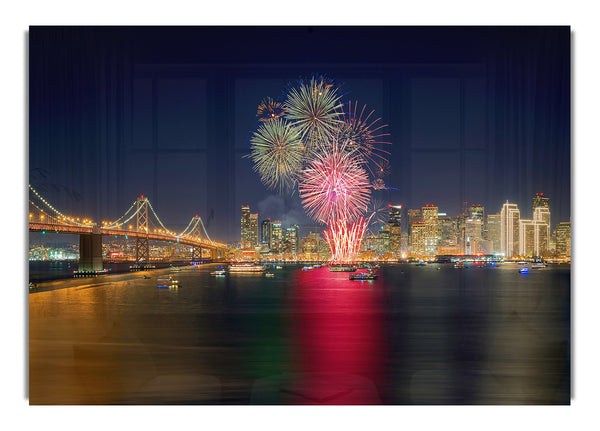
[282,268,385,405]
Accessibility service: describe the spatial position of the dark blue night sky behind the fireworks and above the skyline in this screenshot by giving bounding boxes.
[29,27,571,241]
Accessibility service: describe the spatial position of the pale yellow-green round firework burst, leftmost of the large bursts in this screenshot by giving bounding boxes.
[248,118,302,191]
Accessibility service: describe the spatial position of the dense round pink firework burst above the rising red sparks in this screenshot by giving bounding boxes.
[299,142,371,222]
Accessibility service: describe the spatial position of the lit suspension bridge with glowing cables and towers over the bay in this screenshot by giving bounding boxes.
[29,185,227,273]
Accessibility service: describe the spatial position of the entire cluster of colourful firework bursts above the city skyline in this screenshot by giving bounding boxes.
[246,76,391,262]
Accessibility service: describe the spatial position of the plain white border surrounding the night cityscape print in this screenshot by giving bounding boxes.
[0,0,600,430]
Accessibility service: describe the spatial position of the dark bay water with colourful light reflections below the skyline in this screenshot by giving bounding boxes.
[29,265,570,404]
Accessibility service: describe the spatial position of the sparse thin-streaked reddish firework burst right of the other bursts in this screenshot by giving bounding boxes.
[335,102,391,177]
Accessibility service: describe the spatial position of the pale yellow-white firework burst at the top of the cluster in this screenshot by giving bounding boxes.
[284,77,343,148]
